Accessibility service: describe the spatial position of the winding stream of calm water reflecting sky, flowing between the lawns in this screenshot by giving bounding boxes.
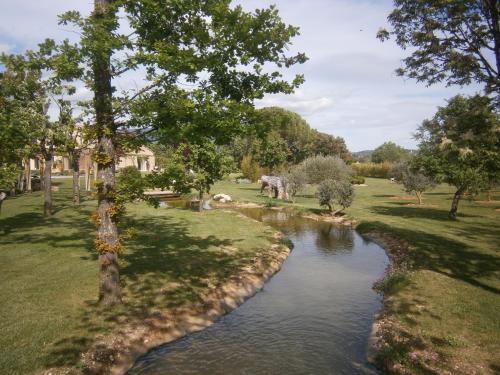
[129,209,387,375]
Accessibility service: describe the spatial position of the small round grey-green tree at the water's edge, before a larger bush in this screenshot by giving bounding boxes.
[318,179,354,216]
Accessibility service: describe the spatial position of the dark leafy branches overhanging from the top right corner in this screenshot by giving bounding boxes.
[378,0,500,100]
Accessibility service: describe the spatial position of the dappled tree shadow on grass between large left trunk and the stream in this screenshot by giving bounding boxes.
[45,212,255,367]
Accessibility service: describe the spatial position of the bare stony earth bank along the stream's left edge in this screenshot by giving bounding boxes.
[76,232,290,375]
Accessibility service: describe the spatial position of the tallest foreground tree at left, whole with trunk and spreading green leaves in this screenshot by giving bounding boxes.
[61,0,306,305]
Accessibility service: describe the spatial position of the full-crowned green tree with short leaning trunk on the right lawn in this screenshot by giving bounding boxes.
[415,95,500,218]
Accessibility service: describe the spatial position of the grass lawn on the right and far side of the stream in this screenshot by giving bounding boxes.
[212,179,500,374]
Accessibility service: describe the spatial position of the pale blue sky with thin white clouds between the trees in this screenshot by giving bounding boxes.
[0,0,481,151]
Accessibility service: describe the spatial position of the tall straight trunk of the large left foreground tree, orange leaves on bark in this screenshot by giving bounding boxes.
[92,0,121,306]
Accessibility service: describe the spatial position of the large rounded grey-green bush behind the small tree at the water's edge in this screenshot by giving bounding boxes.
[300,155,353,184]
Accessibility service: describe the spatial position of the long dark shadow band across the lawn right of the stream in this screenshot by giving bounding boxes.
[358,221,500,294]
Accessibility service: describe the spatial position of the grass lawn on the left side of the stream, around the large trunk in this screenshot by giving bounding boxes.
[0,179,273,374]
